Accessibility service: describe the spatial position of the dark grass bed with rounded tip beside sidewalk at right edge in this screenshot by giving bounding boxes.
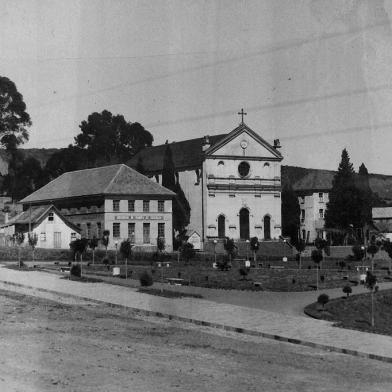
[305,290,392,336]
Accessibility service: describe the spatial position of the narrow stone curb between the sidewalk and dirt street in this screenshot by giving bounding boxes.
[0,280,392,363]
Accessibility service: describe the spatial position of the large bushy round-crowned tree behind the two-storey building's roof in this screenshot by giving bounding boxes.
[75,110,154,166]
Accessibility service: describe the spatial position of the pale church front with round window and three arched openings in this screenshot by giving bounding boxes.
[202,126,282,240]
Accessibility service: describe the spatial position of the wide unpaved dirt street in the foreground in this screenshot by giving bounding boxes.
[0,291,392,392]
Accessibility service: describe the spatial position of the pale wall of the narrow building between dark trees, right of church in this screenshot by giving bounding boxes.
[298,192,329,242]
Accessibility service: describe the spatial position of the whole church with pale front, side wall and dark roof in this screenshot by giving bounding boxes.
[129,122,283,247]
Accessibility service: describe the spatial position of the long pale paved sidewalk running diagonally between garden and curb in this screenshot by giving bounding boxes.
[0,267,392,363]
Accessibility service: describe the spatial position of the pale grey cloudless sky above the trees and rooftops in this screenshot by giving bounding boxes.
[0,0,392,174]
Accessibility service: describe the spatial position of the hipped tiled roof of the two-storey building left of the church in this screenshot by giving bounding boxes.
[20,164,174,204]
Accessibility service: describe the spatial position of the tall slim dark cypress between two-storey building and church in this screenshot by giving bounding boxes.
[162,144,191,234]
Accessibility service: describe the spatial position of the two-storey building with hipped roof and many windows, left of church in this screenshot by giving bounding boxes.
[20,164,174,250]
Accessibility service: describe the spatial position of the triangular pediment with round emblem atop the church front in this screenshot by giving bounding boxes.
[205,124,283,160]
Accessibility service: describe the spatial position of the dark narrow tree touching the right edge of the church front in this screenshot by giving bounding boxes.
[282,184,301,246]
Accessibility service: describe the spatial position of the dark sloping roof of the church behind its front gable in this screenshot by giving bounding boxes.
[127,134,227,174]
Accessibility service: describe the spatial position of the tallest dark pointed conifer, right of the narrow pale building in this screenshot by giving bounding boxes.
[325,149,364,236]
